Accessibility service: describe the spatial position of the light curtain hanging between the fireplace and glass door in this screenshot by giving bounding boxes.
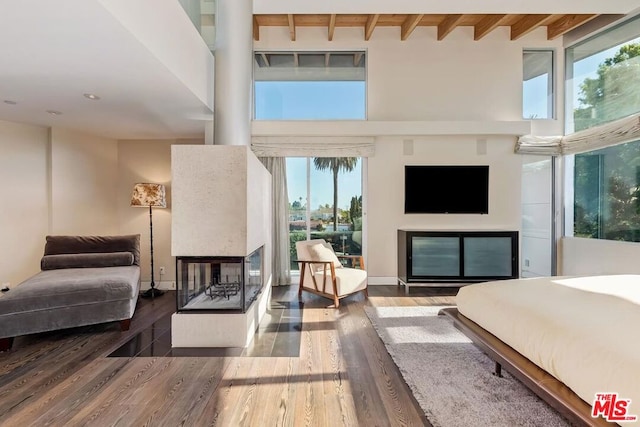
[259,157,291,286]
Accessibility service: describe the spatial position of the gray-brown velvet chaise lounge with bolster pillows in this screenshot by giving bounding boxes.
[0,235,140,351]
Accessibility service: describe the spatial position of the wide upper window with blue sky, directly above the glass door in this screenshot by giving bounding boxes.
[253,51,366,120]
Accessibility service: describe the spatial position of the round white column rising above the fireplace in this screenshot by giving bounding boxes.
[214,0,253,145]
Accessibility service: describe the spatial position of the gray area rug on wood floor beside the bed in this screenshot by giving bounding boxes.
[365,307,571,427]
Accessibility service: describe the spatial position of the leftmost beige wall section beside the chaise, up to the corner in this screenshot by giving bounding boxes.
[0,121,49,285]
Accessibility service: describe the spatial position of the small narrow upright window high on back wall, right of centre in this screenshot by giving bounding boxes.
[522,50,554,119]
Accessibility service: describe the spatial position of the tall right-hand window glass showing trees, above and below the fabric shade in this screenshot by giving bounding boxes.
[565,18,640,242]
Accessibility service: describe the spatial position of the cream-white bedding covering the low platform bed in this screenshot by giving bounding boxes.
[456,275,640,426]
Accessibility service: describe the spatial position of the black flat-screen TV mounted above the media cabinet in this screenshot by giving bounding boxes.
[404,165,489,214]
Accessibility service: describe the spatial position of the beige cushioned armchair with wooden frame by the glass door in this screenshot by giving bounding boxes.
[296,239,369,308]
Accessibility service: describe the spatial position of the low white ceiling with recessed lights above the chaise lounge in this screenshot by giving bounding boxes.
[0,0,212,139]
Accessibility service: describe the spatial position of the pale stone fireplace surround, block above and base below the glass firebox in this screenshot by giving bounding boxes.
[171,145,272,347]
